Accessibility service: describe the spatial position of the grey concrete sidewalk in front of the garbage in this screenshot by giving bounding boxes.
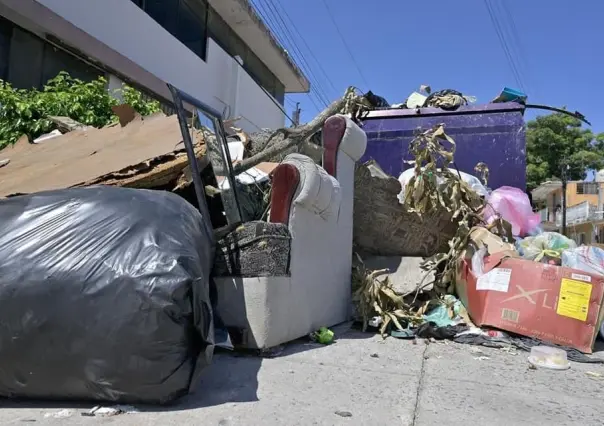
[0,329,604,426]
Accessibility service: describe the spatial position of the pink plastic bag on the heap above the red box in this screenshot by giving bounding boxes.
[484,186,541,237]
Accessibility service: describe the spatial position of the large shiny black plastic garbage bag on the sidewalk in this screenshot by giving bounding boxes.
[0,187,214,404]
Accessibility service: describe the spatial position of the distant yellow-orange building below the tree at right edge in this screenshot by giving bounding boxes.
[532,181,604,244]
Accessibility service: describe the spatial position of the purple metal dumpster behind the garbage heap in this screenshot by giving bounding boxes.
[361,102,526,190]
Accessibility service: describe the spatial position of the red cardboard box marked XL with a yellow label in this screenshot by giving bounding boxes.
[456,253,604,353]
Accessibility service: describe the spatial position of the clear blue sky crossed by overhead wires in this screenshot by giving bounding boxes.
[270,0,604,132]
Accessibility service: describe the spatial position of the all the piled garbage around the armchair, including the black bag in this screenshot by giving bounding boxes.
[0,83,604,415]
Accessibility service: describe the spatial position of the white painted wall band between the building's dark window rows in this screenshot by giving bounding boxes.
[36,0,285,131]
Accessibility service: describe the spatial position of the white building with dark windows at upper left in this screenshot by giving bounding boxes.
[0,0,310,131]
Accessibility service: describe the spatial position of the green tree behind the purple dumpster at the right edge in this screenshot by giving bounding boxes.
[526,113,604,189]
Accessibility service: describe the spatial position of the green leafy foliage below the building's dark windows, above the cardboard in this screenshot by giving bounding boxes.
[0,72,160,149]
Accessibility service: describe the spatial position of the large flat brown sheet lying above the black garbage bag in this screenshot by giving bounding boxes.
[0,114,205,197]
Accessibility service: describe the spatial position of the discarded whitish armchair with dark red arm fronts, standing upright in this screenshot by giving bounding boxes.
[215,115,367,349]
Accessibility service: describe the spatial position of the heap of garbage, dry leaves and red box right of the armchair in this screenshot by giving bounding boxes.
[353,125,604,362]
